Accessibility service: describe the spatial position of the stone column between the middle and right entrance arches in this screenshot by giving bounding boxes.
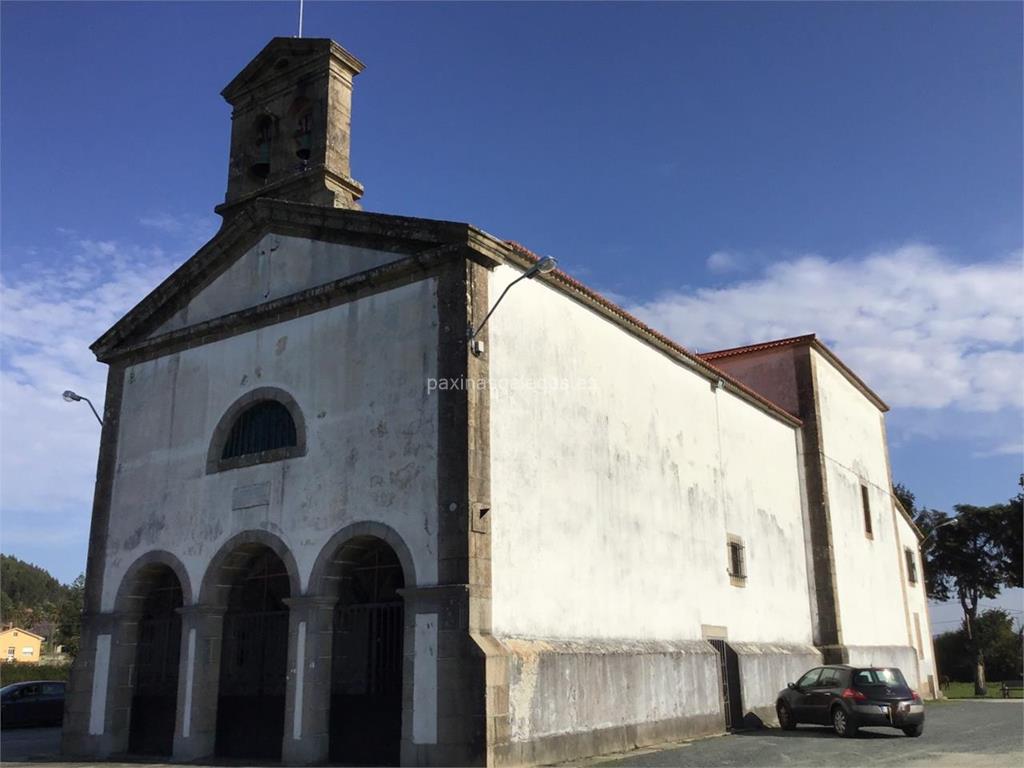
[281,595,338,765]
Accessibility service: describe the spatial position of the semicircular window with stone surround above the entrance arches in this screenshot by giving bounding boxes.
[207,387,306,472]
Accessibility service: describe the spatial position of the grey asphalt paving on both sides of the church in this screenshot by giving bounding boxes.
[0,700,1024,768]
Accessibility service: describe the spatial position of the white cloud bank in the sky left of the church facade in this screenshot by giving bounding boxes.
[0,241,182,578]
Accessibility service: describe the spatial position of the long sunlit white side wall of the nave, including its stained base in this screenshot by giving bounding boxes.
[488,267,820,762]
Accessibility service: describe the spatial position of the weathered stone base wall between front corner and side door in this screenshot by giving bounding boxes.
[486,638,725,766]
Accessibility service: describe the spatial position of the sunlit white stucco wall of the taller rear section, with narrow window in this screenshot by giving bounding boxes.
[811,349,909,646]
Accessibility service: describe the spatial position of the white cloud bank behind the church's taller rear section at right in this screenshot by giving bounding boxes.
[631,244,1024,412]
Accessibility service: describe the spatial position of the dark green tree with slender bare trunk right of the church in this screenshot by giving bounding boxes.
[915,497,1024,695]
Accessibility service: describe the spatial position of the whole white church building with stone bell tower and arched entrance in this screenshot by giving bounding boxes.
[63,38,936,766]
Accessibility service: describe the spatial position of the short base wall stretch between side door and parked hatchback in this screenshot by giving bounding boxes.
[729,642,821,727]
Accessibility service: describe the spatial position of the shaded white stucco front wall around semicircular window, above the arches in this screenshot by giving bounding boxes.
[102,280,437,610]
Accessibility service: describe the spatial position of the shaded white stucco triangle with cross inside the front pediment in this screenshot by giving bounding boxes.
[155,234,401,336]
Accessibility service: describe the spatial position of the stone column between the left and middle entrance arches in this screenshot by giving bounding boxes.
[174,605,224,761]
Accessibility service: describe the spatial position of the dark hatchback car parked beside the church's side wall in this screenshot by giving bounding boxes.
[775,665,925,736]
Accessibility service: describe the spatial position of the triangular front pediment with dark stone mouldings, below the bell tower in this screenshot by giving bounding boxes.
[92,199,489,360]
